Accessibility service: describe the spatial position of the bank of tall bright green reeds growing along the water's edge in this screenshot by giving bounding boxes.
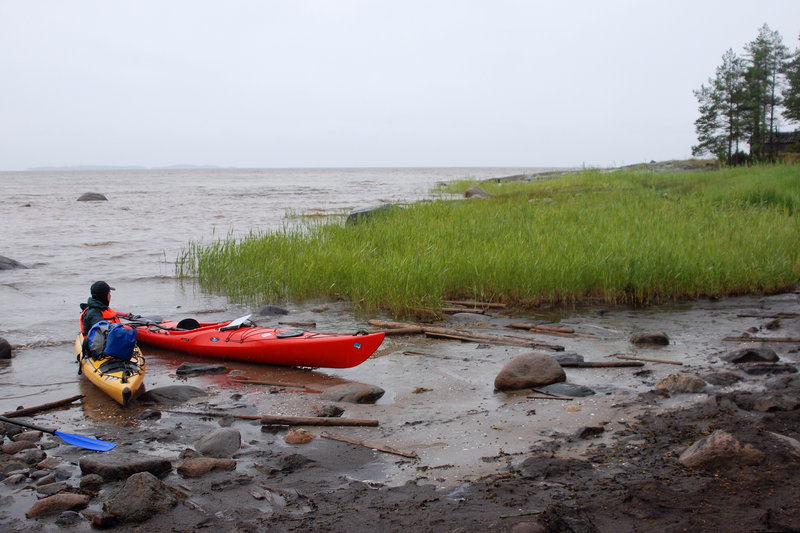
[178,165,800,316]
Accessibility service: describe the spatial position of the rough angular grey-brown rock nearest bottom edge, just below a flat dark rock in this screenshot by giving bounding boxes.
[103,472,180,522]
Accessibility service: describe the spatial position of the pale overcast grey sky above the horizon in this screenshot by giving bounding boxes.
[0,0,800,170]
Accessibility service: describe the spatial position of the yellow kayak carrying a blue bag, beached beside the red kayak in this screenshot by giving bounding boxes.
[75,333,145,407]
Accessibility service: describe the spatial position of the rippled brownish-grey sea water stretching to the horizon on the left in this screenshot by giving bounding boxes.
[0,168,544,412]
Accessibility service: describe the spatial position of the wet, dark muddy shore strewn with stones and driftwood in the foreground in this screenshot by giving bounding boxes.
[0,293,800,532]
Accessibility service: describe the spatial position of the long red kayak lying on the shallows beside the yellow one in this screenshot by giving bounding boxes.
[132,317,384,368]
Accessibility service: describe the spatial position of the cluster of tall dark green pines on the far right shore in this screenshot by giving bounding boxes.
[692,24,800,164]
